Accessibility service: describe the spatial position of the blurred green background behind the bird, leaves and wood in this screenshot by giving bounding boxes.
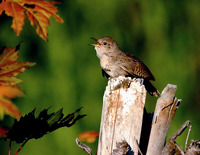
[0,0,200,155]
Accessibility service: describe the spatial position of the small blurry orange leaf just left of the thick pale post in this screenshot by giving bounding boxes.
[78,131,99,143]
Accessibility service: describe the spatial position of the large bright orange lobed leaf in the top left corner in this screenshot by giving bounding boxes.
[0,0,63,41]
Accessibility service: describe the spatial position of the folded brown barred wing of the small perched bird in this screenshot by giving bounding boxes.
[119,53,155,80]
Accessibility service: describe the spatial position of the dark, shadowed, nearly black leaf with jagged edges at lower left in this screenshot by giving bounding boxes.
[5,108,86,143]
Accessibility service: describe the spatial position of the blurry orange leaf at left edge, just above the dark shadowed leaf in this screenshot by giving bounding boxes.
[0,85,23,119]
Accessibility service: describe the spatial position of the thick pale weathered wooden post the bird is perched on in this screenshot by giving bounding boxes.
[98,77,146,155]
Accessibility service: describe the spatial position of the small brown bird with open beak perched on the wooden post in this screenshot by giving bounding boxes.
[91,37,160,96]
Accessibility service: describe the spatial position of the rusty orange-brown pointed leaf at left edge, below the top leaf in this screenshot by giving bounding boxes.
[0,44,36,85]
